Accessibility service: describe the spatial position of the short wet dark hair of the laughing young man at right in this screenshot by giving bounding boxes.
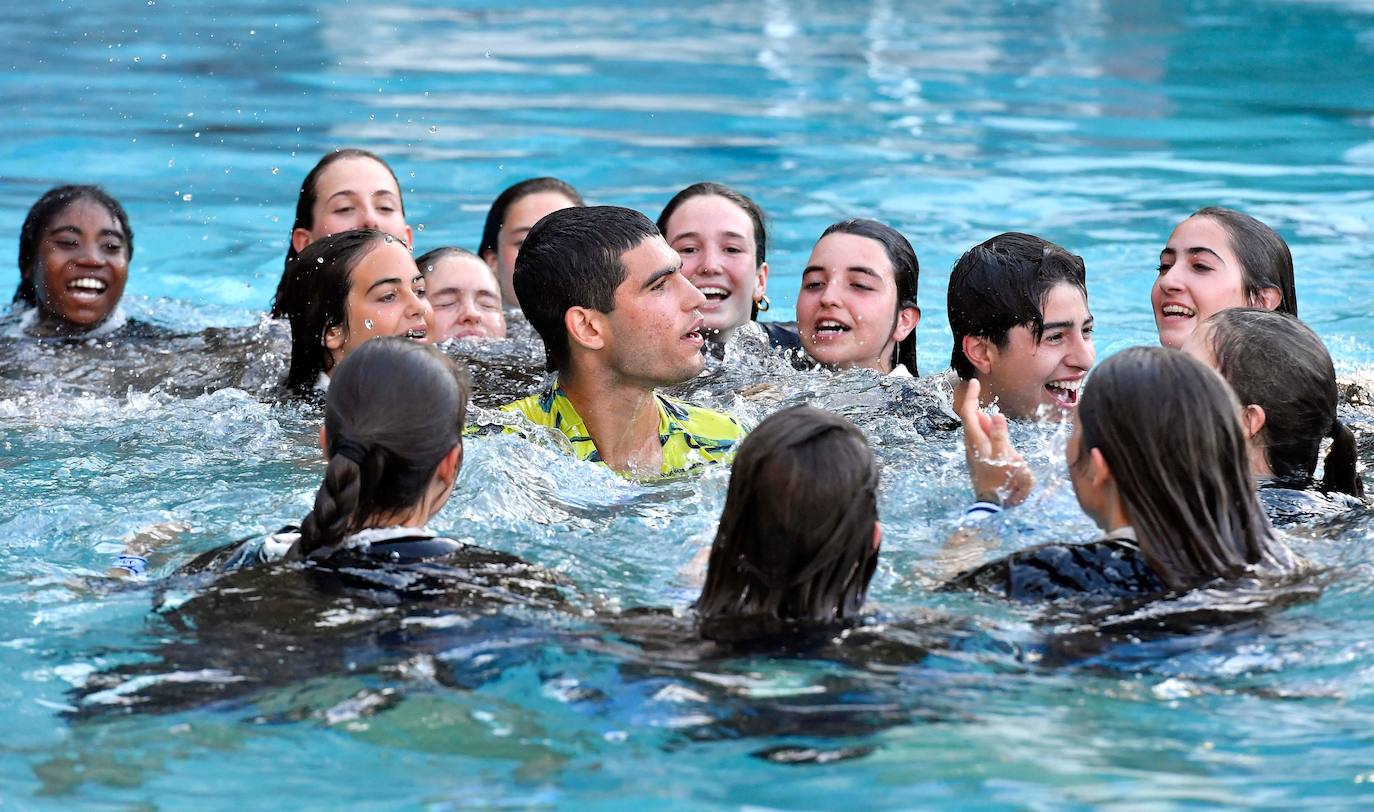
[947,231,1088,381]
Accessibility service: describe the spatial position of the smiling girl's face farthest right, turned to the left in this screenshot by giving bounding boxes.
[1150,217,1272,348]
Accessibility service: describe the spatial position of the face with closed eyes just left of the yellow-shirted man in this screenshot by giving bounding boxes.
[425,254,506,341]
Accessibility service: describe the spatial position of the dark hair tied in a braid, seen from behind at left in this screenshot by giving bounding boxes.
[298,337,470,555]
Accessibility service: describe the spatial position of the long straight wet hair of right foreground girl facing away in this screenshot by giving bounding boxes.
[1070,346,1290,591]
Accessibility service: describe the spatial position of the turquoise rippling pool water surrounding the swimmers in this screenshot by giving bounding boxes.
[0,0,1374,809]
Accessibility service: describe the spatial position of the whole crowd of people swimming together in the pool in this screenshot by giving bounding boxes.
[11,150,1363,634]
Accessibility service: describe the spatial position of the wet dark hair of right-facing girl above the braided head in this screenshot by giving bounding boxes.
[272,228,404,390]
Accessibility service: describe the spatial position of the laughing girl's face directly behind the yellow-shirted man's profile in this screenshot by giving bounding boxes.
[664,195,768,342]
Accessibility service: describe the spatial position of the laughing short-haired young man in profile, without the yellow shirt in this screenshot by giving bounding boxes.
[948,232,1098,419]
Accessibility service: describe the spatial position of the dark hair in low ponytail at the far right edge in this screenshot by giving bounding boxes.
[1204,308,1364,496]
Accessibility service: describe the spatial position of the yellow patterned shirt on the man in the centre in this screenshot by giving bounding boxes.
[502,381,745,475]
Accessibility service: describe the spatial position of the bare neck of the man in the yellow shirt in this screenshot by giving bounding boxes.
[558,363,664,475]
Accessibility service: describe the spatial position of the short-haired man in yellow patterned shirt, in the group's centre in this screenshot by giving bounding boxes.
[503,206,743,477]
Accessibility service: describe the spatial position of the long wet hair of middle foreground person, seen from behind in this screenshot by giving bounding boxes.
[697,407,878,622]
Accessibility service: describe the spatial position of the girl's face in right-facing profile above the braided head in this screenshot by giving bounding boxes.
[323,240,434,368]
